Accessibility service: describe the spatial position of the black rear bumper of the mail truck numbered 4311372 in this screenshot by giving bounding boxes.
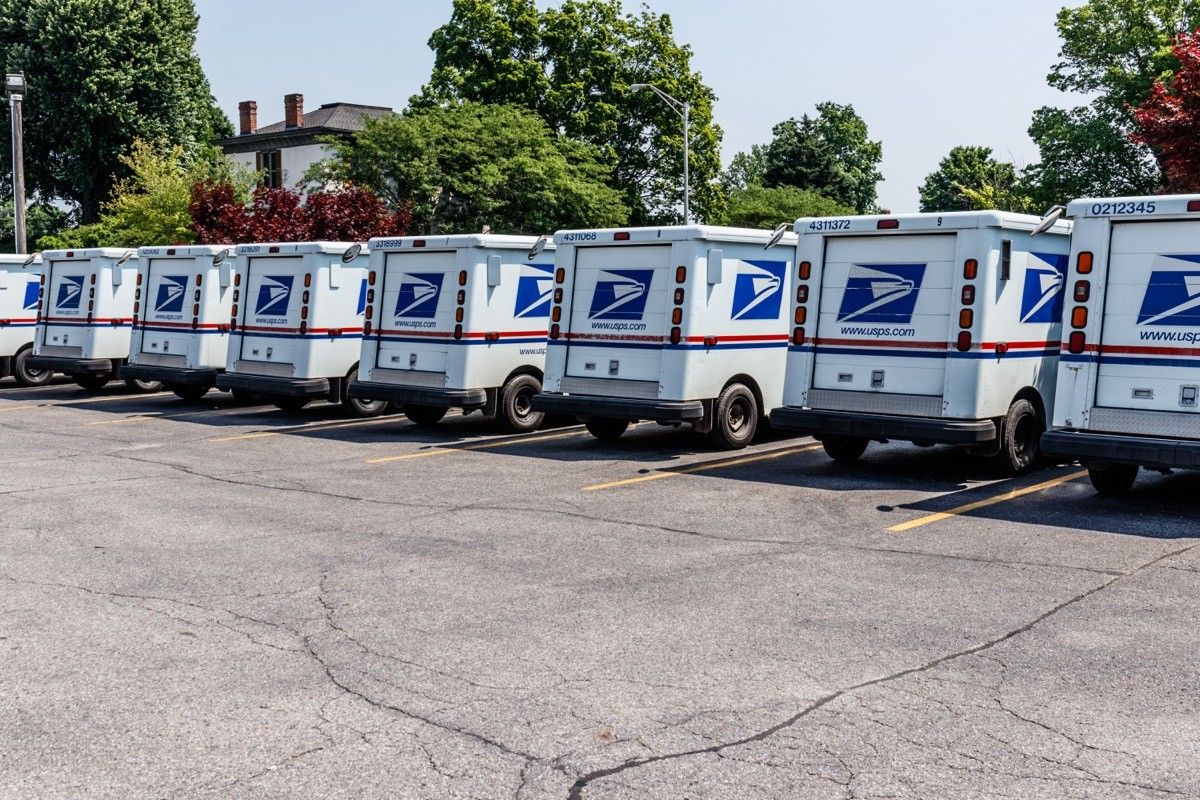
[770,405,997,445]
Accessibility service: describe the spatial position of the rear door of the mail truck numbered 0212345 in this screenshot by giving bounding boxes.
[1096,221,1200,414]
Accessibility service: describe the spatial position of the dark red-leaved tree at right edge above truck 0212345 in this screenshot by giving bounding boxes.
[1133,31,1200,193]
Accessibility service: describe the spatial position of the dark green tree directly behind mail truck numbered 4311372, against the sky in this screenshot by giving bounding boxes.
[763,103,883,213]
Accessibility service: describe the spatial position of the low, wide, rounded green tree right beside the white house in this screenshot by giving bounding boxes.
[310,103,629,234]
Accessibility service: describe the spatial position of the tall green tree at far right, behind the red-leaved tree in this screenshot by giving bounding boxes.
[1028,0,1200,204]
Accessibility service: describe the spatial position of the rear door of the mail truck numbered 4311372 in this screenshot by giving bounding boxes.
[812,234,956,396]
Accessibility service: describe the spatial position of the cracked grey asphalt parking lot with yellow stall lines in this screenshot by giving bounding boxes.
[0,381,1200,800]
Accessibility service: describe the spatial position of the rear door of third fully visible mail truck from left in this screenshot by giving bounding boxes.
[241,255,305,363]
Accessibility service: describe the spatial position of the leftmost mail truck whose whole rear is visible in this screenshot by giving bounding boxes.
[29,248,162,391]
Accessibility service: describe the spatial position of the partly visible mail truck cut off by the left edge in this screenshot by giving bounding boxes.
[0,254,54,386]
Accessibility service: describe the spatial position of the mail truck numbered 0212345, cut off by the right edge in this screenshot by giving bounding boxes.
[1043,194,1200,494]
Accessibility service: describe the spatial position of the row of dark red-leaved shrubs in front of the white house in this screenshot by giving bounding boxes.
[188,184,408,245]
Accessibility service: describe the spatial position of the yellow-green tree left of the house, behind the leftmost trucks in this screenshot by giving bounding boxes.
[37,139,254,249]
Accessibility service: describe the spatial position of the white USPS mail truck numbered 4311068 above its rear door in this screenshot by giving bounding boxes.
[534,225,796,449]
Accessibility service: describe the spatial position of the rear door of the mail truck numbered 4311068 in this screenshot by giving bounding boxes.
[566,245,673,381]
